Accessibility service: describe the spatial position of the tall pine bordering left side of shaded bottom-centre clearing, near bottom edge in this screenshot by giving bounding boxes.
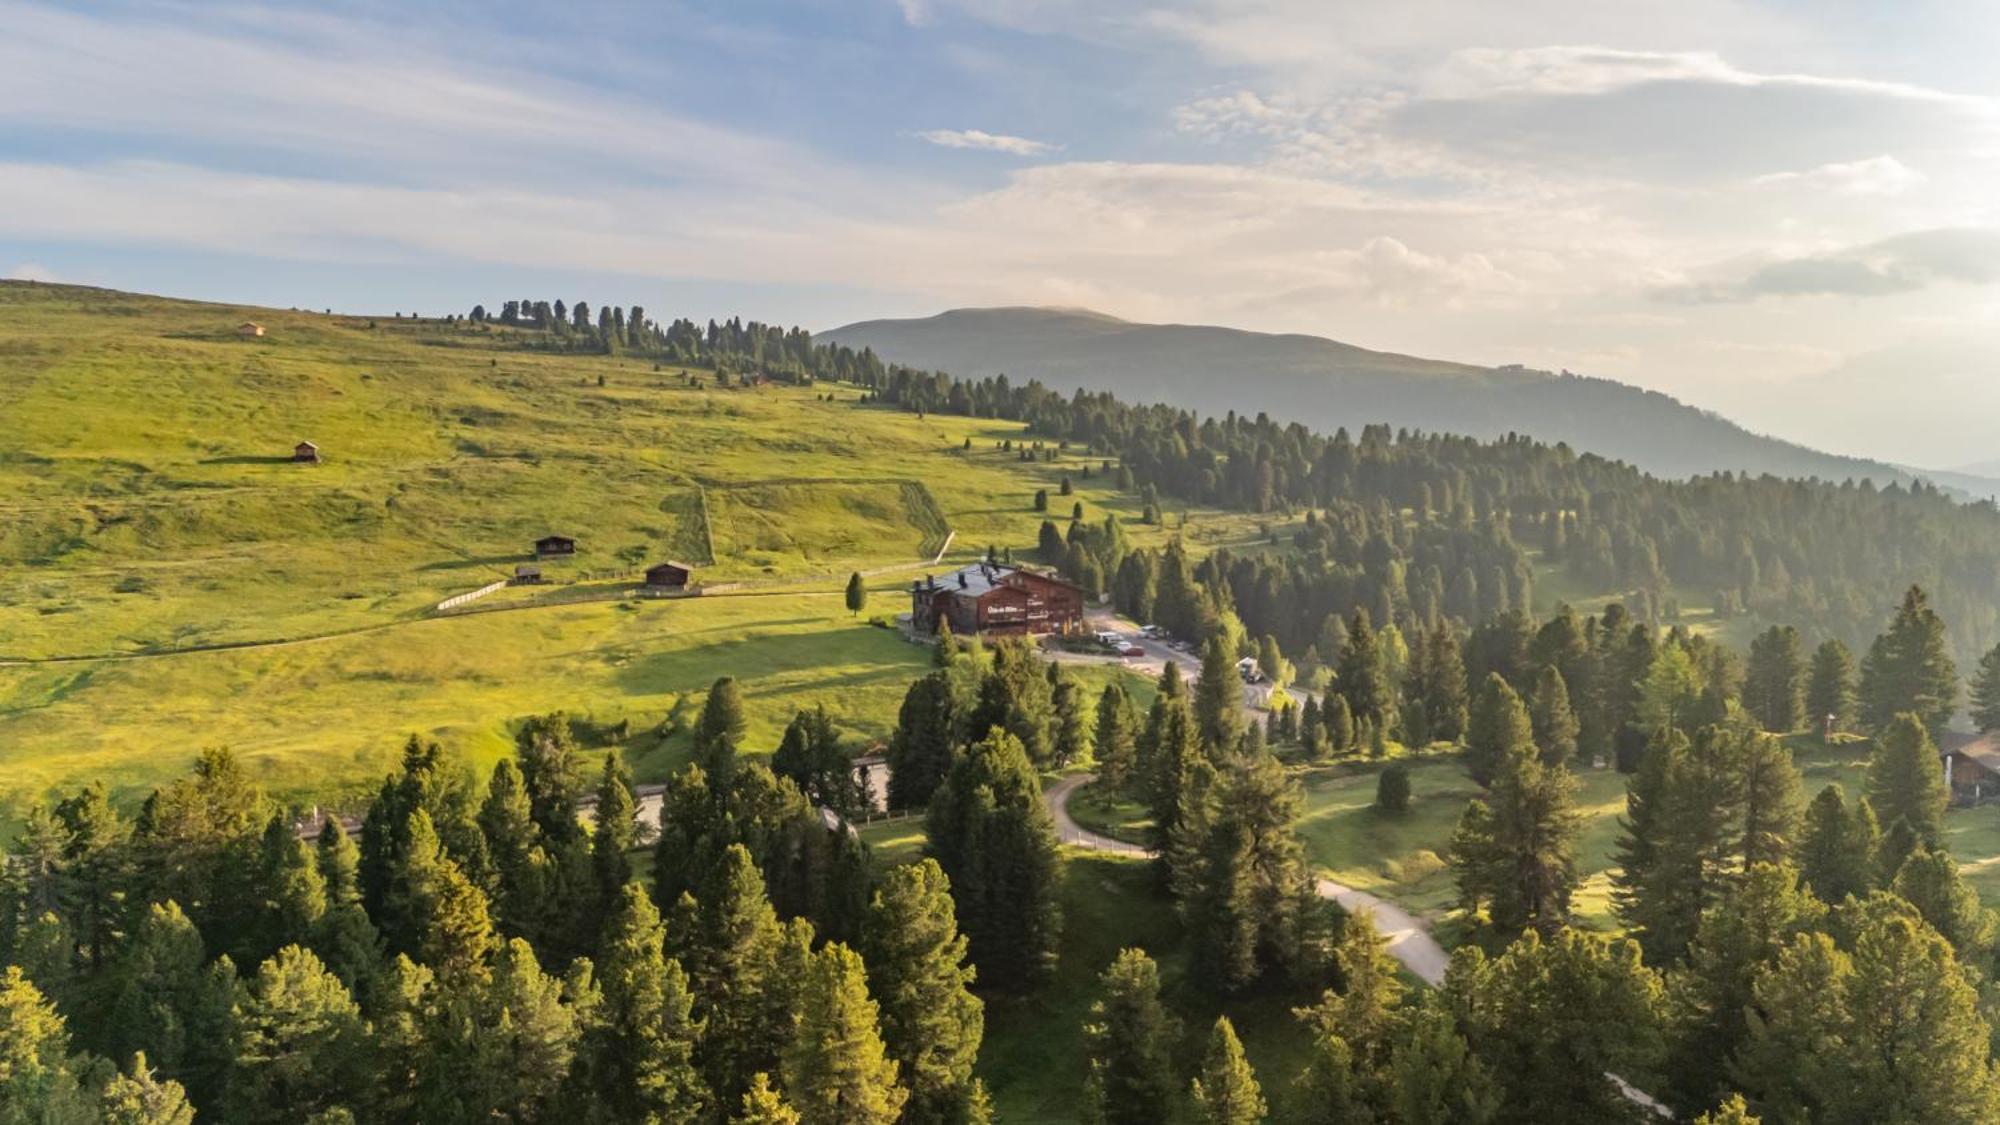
[862,859,986,1125]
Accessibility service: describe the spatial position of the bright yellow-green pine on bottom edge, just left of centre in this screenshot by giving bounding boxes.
[784,943,910,1125]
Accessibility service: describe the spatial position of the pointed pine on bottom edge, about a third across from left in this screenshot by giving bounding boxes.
[586,885,710,1121]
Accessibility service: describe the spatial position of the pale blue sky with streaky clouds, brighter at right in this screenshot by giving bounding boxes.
[0,0,2000,468]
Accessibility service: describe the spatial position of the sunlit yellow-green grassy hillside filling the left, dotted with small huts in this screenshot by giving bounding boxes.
[0,282,1280,825]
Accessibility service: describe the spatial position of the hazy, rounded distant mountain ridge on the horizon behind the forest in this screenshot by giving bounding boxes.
[814,308,1942,484]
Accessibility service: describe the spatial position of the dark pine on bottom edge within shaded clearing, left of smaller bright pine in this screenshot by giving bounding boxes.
[1084,949,1180,1125]
